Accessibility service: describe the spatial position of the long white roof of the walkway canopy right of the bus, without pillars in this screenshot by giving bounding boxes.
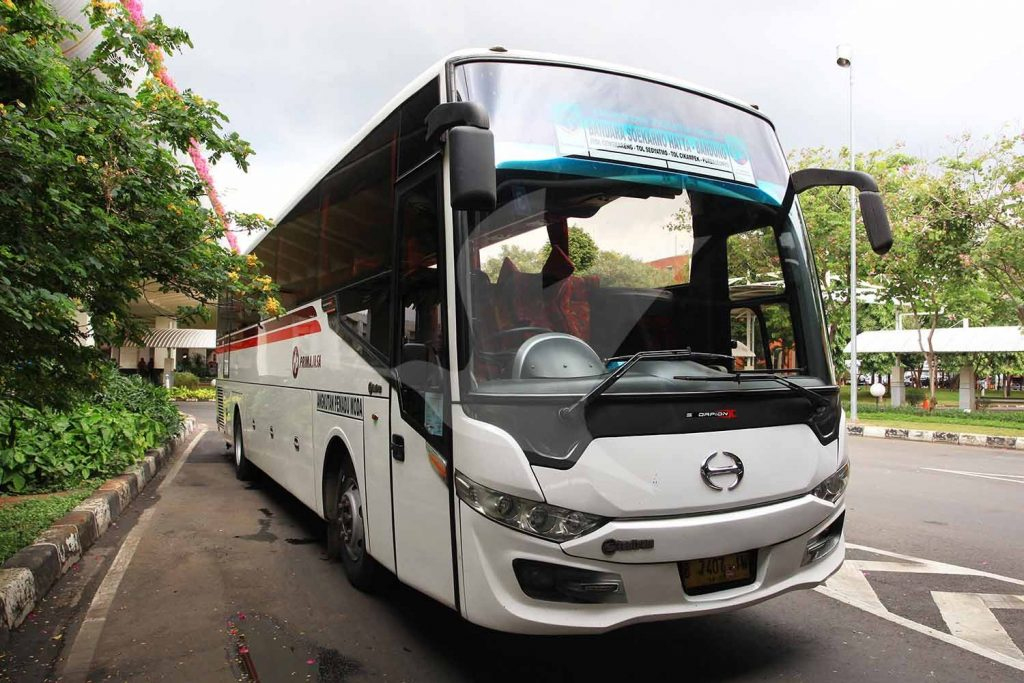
[846,326,1024,354]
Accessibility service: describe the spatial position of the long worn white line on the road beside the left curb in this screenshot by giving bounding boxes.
[58,427,207,683]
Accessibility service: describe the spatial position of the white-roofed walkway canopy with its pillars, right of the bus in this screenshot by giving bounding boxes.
[845,324,1024,411]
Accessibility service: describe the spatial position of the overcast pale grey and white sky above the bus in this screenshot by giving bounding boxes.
[144,0,1024,245]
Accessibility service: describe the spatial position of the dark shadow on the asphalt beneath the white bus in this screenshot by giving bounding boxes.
[224,456,794,681]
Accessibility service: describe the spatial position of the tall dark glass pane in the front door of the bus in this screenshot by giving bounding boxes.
[395,175,445,439]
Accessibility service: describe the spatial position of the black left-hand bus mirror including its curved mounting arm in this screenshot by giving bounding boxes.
[426,102,498,211]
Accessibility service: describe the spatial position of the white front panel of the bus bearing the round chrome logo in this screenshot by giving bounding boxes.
[534,425,840,518]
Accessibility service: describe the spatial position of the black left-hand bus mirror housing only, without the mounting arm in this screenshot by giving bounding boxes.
[447,126,498,211]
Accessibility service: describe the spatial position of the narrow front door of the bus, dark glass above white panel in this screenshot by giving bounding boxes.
[390,164,455,605]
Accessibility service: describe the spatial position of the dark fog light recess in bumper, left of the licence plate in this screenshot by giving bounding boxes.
[512,559,626,603]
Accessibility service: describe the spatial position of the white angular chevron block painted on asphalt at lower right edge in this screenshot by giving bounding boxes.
[932,591,1024,661]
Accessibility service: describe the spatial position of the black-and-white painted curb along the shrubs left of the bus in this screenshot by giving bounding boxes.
[0,416,197,645]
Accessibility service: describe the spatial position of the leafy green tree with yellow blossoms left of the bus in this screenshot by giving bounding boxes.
[0,0,280,407]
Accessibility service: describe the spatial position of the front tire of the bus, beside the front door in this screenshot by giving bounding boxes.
[327,458,383,593]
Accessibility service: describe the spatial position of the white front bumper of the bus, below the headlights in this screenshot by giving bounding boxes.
[459,502,846,635]
